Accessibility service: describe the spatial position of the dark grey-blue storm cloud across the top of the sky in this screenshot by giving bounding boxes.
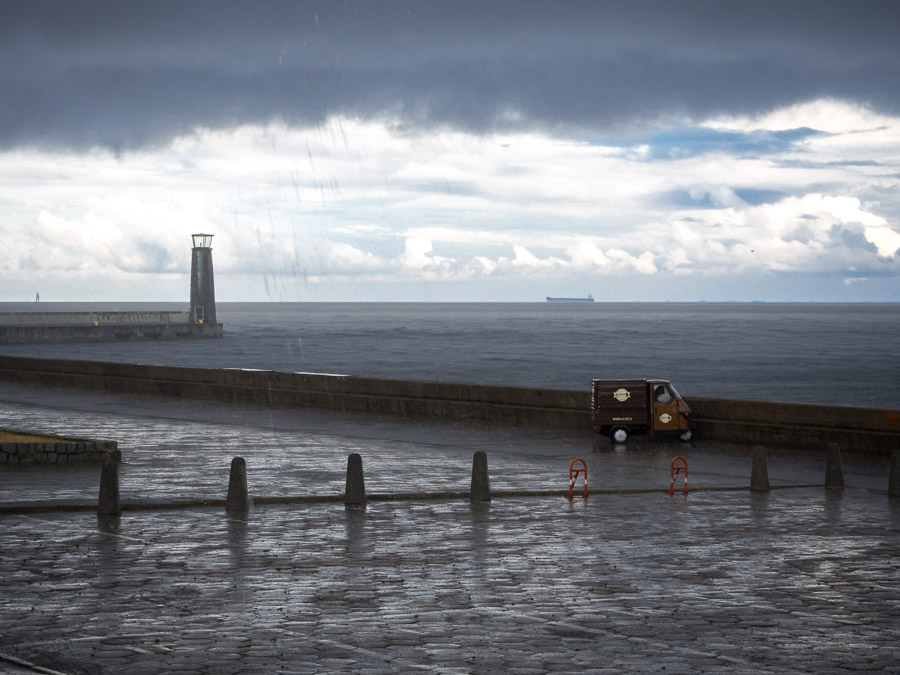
[0,0,900,148]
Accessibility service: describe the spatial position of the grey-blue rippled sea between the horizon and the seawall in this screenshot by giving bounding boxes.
[0,302,900,408]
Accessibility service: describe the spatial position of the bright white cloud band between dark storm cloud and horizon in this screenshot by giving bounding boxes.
[0,101,900,299]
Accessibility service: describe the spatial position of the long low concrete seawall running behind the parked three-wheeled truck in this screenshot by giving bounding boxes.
[0,356,900,454]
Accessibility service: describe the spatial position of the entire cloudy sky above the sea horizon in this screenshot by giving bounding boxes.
[0,0,900,302]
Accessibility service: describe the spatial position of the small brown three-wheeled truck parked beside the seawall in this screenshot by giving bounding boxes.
[591,380,692,443]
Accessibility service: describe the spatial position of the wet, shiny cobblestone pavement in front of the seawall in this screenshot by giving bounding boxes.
[0,385,900,675]
